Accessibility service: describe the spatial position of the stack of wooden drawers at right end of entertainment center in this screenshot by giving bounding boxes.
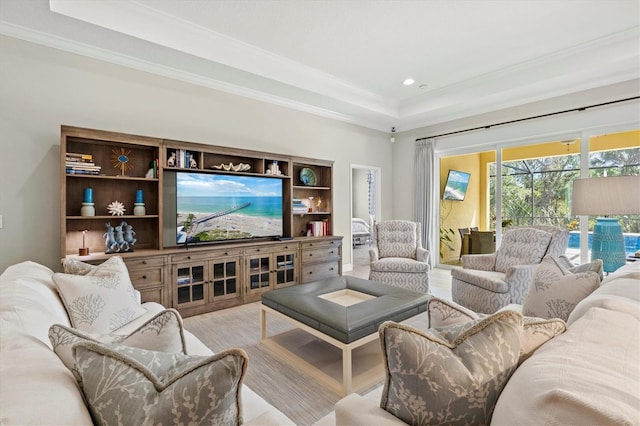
[300,237,342,283]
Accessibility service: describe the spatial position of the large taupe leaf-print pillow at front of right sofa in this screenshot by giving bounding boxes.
[379,311,522,425]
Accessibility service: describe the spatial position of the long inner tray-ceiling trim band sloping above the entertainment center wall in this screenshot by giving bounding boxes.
[49,0,398,116]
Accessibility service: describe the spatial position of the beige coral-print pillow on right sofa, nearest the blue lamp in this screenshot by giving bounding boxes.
[522,256,600,322]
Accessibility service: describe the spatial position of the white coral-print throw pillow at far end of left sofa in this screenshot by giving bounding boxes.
[53,256,146,334]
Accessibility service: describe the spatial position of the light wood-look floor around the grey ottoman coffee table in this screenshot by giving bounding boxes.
[184,262,451,425]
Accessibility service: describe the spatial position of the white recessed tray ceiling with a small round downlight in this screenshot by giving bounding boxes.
[0,0,640,131]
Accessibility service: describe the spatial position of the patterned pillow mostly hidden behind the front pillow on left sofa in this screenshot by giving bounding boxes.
[49,309,187,383]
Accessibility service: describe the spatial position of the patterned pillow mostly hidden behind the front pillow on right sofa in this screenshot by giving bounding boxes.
[427,297,567,365]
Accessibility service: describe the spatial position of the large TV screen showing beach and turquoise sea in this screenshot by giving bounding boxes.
[176,173,282,244]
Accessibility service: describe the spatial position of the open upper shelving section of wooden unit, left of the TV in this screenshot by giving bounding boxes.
[60,126,162,257]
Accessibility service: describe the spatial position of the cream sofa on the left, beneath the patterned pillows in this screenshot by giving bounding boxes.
[0,262,293,425]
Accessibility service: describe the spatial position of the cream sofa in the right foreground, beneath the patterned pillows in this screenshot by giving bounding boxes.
[318,262,640,425]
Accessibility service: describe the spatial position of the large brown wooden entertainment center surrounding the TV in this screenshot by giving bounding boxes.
[60,126,342,316]
